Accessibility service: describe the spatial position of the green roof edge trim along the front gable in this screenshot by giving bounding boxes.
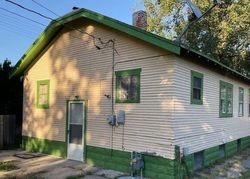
[10,8,181,78]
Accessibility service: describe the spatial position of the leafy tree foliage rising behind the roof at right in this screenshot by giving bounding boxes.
[142,0,250,76]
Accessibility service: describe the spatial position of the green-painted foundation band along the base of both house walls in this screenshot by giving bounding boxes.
[22,136,250,179]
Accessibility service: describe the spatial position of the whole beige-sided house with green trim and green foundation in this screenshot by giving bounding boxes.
[12,9,250,179]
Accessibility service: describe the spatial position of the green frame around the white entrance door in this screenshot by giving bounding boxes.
[65,100,88,162]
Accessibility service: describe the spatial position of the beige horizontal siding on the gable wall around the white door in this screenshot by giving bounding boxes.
[23,21,176,158]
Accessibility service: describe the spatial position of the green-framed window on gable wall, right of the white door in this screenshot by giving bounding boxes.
[115,69,141,103]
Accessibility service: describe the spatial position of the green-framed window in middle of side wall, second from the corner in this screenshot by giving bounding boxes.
[220,81,233,117]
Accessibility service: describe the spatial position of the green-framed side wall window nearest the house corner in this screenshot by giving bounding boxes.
[191,71,203,104]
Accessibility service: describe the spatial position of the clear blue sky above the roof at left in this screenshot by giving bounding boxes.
[0,0,144,65]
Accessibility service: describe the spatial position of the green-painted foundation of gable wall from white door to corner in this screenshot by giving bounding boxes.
[86,146,179,179]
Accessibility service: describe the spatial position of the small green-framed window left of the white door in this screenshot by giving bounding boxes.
[37,80,50,109]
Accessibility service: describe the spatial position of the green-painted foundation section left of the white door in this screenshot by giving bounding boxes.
[22,136,67,158]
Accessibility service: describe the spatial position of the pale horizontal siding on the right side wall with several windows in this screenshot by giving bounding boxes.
[172,59,250,153]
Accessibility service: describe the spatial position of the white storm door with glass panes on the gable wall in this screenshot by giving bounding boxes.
[67,101,85,161]
